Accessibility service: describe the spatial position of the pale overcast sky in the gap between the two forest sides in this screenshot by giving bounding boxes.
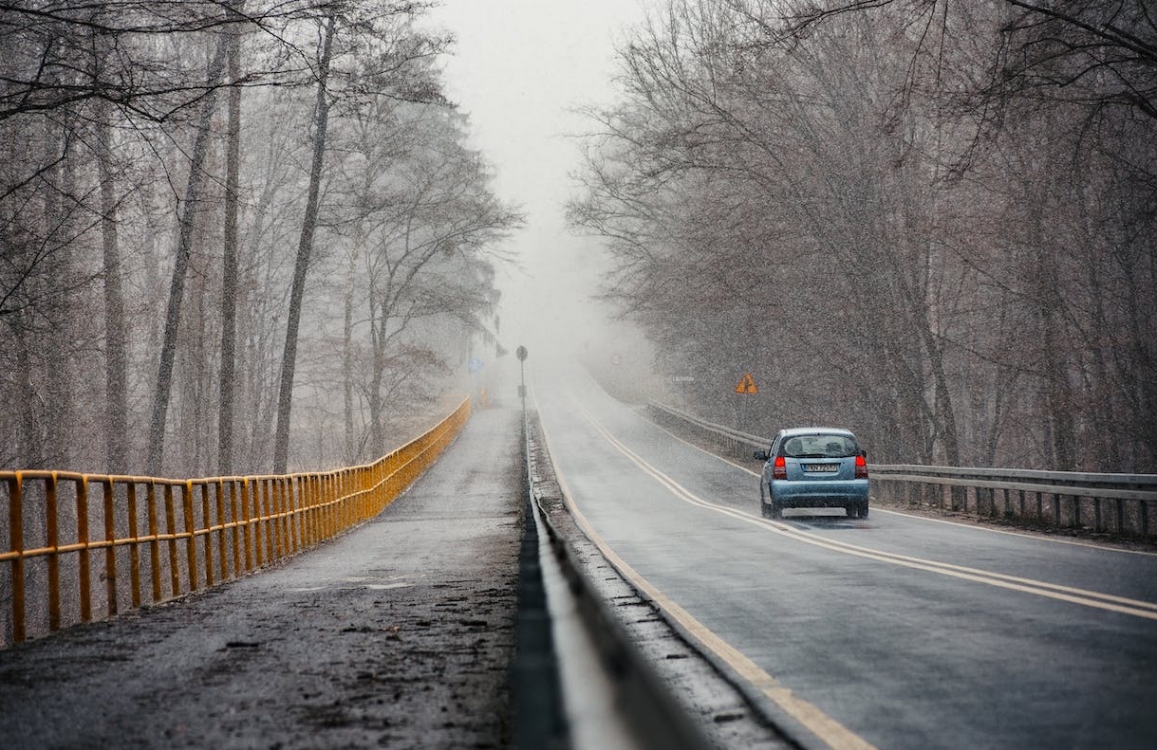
[432,0,644,356]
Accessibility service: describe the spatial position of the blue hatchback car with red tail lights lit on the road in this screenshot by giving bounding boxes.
[756,427,868,519]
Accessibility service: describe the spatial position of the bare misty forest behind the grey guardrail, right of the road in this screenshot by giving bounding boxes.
[568,0,1157,472]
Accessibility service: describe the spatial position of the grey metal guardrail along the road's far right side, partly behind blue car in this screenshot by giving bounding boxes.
[647,402,1157,537]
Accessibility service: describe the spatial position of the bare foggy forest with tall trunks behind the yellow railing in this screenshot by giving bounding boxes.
[0,0,523,477]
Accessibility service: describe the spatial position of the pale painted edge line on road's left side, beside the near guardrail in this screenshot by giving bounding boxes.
[535,388,877,750]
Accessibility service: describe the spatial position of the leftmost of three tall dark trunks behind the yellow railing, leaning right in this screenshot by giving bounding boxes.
[147,36,228,477]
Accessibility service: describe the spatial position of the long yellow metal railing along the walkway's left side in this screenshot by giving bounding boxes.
[0,399,470,648]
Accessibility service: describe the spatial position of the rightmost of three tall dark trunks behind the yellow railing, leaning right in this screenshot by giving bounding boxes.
[273,16,337,473]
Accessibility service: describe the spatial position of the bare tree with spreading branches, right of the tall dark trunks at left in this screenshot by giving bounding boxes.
[334,77,521,461]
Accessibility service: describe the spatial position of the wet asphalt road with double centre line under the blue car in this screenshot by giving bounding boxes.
[533,369,1157,750]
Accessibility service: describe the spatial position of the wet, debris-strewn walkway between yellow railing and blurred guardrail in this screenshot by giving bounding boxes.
[0,410,521,750]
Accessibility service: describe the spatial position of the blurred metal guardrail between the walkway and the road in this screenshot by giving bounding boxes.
[511,412,713,750]
